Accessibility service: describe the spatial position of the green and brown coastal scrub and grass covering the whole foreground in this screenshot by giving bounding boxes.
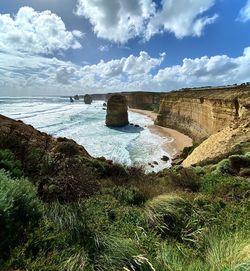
[0,116,250,271]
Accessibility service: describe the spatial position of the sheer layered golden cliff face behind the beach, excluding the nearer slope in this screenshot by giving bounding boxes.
[156,87,250,141]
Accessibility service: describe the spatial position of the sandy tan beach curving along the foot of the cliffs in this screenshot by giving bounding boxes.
[129,108,193,158]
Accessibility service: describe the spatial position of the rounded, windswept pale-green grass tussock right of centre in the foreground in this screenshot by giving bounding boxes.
[147,194,192,238]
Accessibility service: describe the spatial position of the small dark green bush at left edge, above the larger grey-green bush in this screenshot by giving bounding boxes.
[0,149,22,177]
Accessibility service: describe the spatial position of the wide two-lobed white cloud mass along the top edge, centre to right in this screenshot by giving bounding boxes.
[76,0,218,43]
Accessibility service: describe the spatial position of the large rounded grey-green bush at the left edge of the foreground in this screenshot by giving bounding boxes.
[0,172,41,262]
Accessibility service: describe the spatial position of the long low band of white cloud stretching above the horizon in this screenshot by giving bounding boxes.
[0,47,250,96]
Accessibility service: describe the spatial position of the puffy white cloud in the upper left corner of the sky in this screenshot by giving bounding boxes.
[0,7,83,54]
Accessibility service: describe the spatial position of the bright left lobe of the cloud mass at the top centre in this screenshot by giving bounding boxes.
[76,0,155,43]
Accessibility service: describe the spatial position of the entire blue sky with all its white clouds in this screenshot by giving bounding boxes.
[0,0,250,96]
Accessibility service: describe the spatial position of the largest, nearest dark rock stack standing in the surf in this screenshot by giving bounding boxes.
[106,94,129,127]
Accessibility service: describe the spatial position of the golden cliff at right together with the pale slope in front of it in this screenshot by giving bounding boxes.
[156,86,250,167]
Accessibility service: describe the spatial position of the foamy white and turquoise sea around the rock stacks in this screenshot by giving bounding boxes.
[0,97,171,171]
